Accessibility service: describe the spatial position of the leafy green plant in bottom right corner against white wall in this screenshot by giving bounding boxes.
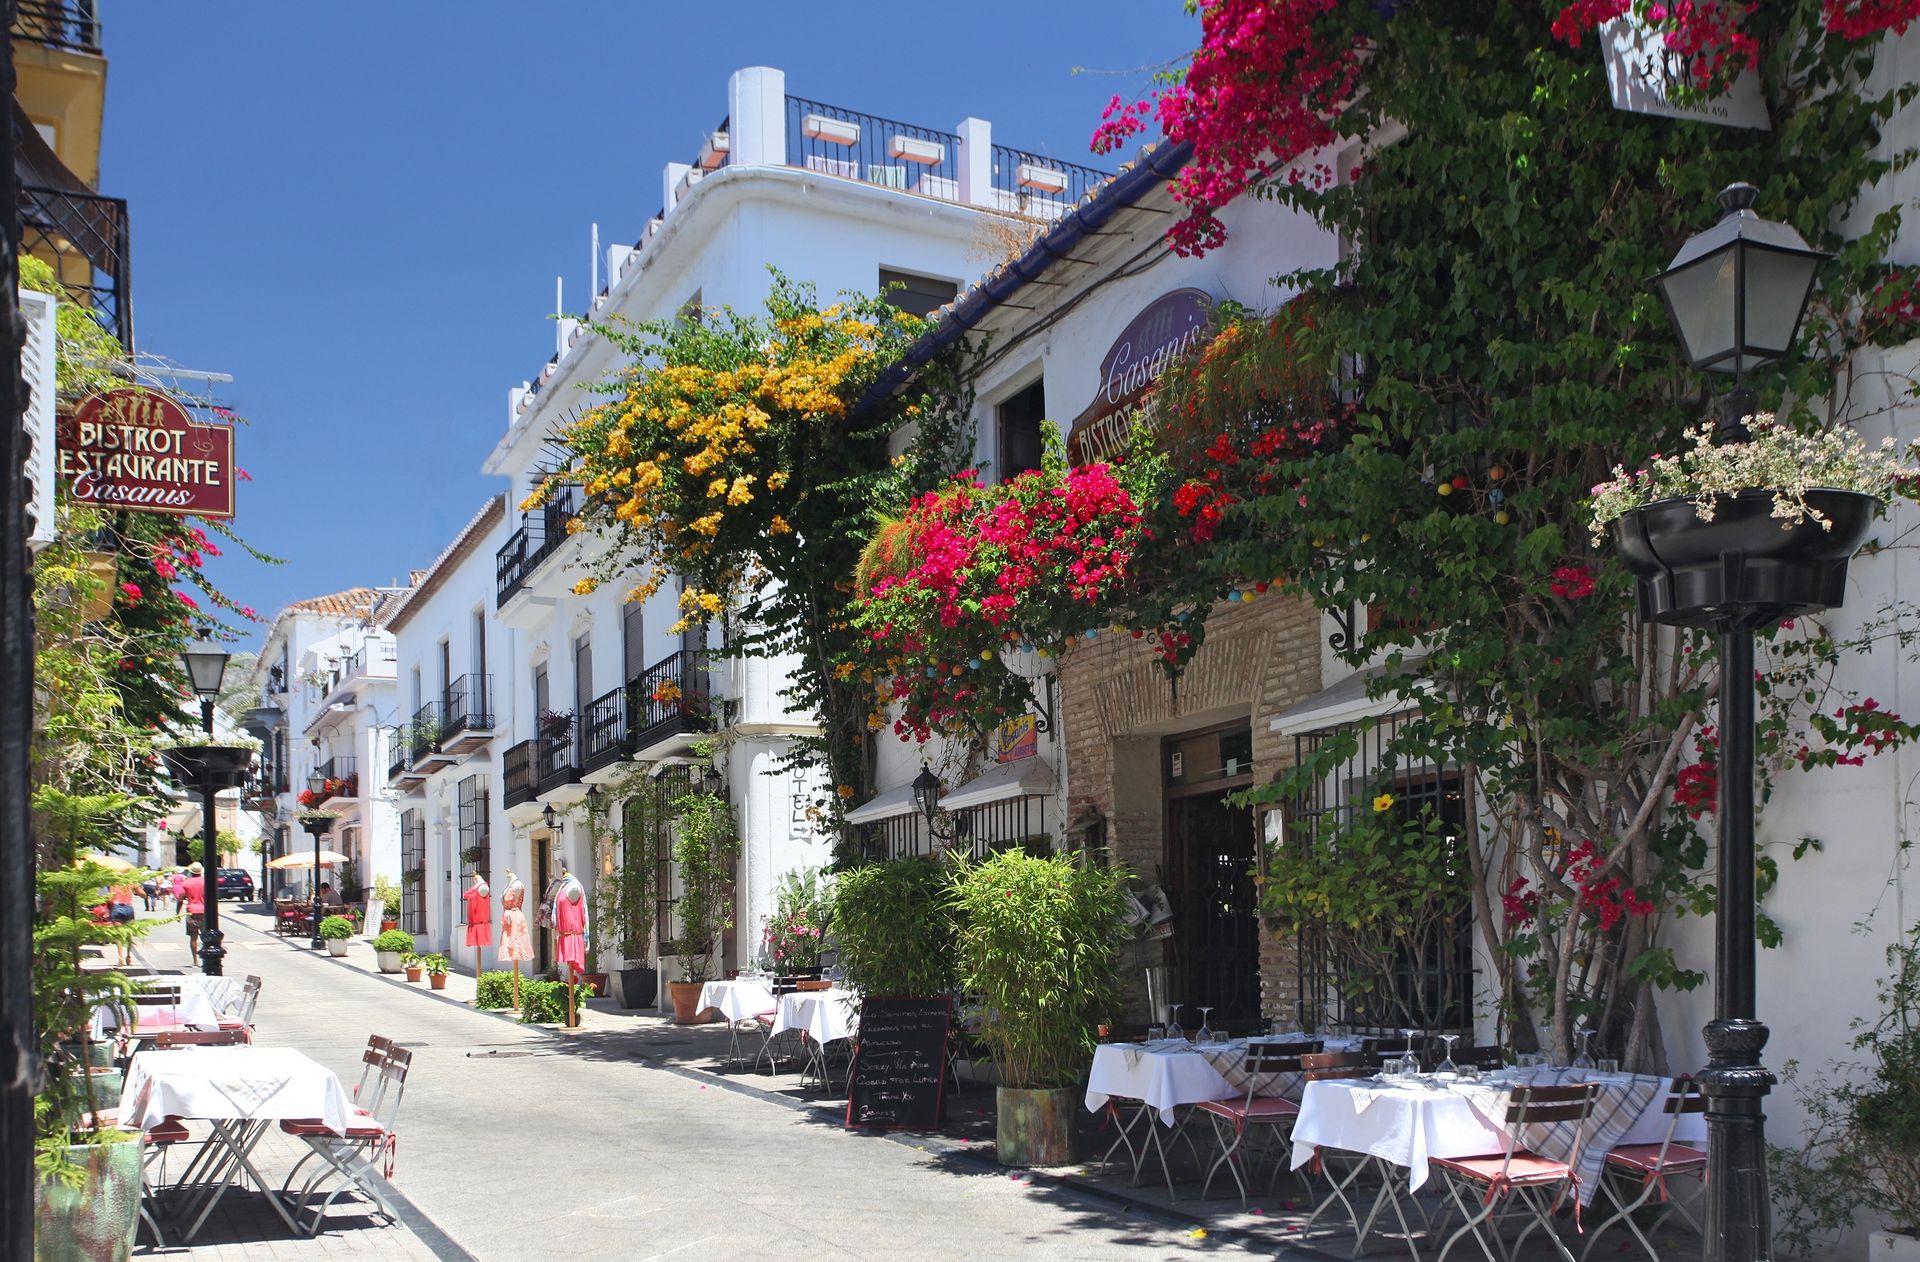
[1770,924,1920,1262]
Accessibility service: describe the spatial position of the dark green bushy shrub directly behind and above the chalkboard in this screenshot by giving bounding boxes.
[831,859,958,995]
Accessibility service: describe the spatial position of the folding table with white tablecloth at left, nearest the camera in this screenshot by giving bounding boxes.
[119,1045,353,1243]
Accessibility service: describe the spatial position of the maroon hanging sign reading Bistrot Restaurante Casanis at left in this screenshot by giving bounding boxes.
[58,386,234,517]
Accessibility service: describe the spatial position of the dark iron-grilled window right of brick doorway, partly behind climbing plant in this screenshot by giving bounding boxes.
[1279,715,1473,1033]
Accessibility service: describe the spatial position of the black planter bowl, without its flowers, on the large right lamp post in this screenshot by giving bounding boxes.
[1613,490,1880,626]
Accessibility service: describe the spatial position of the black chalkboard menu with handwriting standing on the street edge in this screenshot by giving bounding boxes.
[847,997,952,1131]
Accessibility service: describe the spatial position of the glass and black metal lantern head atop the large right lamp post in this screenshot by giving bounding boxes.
[1653,184,1830,376]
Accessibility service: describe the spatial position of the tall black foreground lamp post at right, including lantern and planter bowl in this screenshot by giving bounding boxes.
[1643,184,1835,1262]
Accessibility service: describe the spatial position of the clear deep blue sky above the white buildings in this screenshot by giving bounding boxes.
[100,0,1198,641]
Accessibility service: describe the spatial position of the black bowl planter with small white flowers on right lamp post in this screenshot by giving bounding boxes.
[1594,413,1901,624]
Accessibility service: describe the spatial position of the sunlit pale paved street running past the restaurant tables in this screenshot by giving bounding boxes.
[144,905,1275,1260]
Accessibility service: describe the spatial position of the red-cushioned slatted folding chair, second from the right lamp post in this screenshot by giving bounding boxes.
[1432,1083,1599,1262]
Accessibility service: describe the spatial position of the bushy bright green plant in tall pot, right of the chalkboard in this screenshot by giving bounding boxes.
[952,851,1127,1166]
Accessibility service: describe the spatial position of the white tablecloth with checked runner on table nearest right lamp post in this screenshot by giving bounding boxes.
[1292,1070,1707,1202]
